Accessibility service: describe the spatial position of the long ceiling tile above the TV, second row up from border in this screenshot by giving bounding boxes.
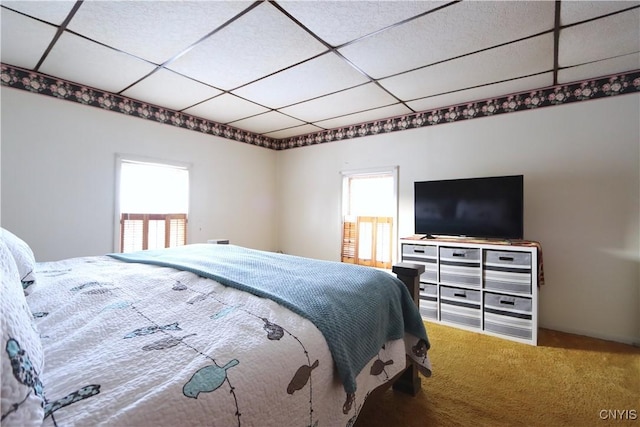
[380,34,553,101]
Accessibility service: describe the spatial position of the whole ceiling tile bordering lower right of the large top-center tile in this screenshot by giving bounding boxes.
[233,53,369,108]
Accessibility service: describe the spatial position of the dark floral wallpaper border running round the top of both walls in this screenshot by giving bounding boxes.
[0,64,640,150]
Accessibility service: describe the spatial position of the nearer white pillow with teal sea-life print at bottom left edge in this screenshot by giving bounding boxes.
[0,239,44,427]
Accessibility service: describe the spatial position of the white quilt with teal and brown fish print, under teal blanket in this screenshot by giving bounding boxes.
[21,245,430,427]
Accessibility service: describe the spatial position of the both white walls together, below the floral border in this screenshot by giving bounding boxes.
[0,87,640,348]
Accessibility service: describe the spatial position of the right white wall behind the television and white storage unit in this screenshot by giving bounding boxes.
[278,94,640,342]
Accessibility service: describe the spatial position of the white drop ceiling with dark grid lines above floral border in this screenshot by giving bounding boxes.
[1,0,640,144]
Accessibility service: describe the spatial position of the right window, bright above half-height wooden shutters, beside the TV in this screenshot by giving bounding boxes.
[341,168,398,268]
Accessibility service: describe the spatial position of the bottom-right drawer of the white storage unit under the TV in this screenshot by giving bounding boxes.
[484,292,533,339]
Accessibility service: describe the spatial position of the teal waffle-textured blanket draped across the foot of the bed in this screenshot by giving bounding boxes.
[110,244,429,393]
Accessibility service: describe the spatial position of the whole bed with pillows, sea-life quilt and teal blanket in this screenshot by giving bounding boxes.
[0,230,431,427]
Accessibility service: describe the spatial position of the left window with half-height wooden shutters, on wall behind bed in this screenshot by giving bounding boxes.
[117,158,189,252]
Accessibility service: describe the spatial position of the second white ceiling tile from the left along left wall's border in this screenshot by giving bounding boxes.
[40,33,155,93]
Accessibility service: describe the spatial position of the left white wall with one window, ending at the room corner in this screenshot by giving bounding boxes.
[0,87,277,261]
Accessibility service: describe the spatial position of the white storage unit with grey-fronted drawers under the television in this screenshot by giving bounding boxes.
[400,236,540,345]
